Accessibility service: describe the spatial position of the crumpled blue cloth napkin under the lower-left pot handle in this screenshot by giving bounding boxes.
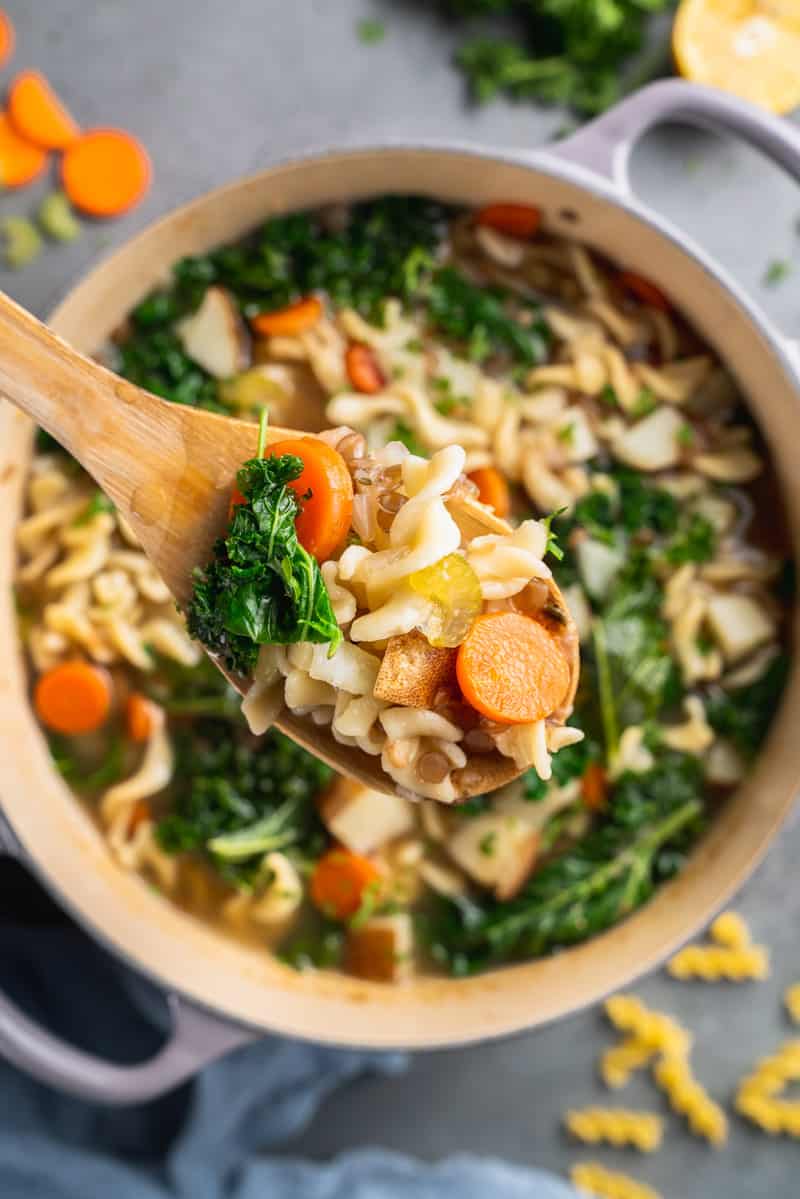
[0,926,575,1199]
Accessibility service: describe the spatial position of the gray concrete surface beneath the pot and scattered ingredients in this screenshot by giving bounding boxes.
[6,0,800,1199]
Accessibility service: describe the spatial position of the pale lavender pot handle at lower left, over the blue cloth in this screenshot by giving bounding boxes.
[0,813,257,1105]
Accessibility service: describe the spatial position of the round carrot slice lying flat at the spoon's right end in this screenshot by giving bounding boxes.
[456,611,570,724]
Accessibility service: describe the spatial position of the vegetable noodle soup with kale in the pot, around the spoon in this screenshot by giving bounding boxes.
[17,197,792,982]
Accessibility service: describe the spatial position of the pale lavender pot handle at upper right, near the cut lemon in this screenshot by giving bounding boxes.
[537,79,800,378]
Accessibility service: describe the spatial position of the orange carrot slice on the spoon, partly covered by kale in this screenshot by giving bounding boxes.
[265,438,353,562]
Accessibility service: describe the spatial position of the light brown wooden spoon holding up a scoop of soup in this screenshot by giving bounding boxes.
[0,293,578,799]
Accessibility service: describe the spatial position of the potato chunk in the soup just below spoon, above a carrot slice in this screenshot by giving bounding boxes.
[319,778,416,854]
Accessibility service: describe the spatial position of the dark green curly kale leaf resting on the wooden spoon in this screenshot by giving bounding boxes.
[187,454,342,675]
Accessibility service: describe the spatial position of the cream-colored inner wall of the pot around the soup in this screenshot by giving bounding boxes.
[0,150,800,1047]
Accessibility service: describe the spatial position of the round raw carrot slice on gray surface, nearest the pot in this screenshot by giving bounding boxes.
[61,129,152,217]
